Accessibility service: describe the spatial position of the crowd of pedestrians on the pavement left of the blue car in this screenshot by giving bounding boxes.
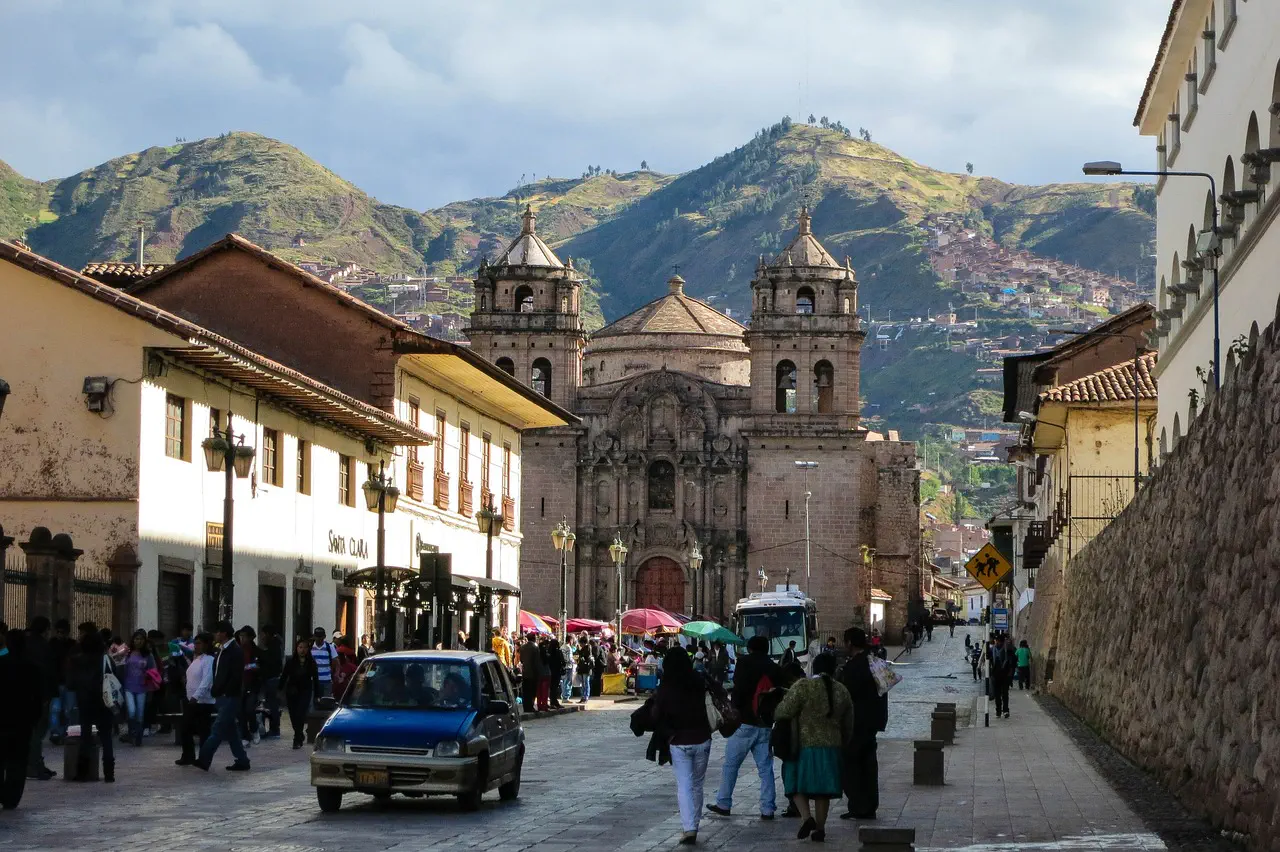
[0,615,372,809]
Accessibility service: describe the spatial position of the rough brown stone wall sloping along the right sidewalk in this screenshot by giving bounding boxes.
[1033,313,1280,849]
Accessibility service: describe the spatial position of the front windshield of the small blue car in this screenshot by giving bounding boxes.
[342,658,474,710]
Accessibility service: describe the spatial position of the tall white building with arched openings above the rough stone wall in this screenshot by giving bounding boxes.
[1134,0,1280,452]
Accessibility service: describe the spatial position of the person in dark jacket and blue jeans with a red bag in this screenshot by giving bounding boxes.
[707,636,782,820]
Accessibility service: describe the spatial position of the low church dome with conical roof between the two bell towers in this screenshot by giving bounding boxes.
[584,275,750,385]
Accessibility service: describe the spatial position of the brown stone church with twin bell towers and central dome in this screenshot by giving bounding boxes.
[467,204,920,633]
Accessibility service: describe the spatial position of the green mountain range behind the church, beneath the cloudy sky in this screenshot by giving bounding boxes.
[0,125,1155,435]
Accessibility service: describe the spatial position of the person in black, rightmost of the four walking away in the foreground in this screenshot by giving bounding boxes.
[840,627,888,820]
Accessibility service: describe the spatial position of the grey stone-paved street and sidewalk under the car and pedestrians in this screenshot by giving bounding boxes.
[0,629,1233,852]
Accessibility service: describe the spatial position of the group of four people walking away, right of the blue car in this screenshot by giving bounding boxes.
[631,627,888,844]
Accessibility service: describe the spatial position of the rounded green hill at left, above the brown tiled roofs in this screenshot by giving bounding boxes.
[7,133,440,271]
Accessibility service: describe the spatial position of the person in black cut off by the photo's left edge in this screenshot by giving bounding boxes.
[0,622,47,810]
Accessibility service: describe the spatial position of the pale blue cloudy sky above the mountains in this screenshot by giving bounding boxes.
[0,0,1171,210]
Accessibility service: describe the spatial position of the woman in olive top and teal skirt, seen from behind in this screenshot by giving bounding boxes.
[774,654,854,843]
